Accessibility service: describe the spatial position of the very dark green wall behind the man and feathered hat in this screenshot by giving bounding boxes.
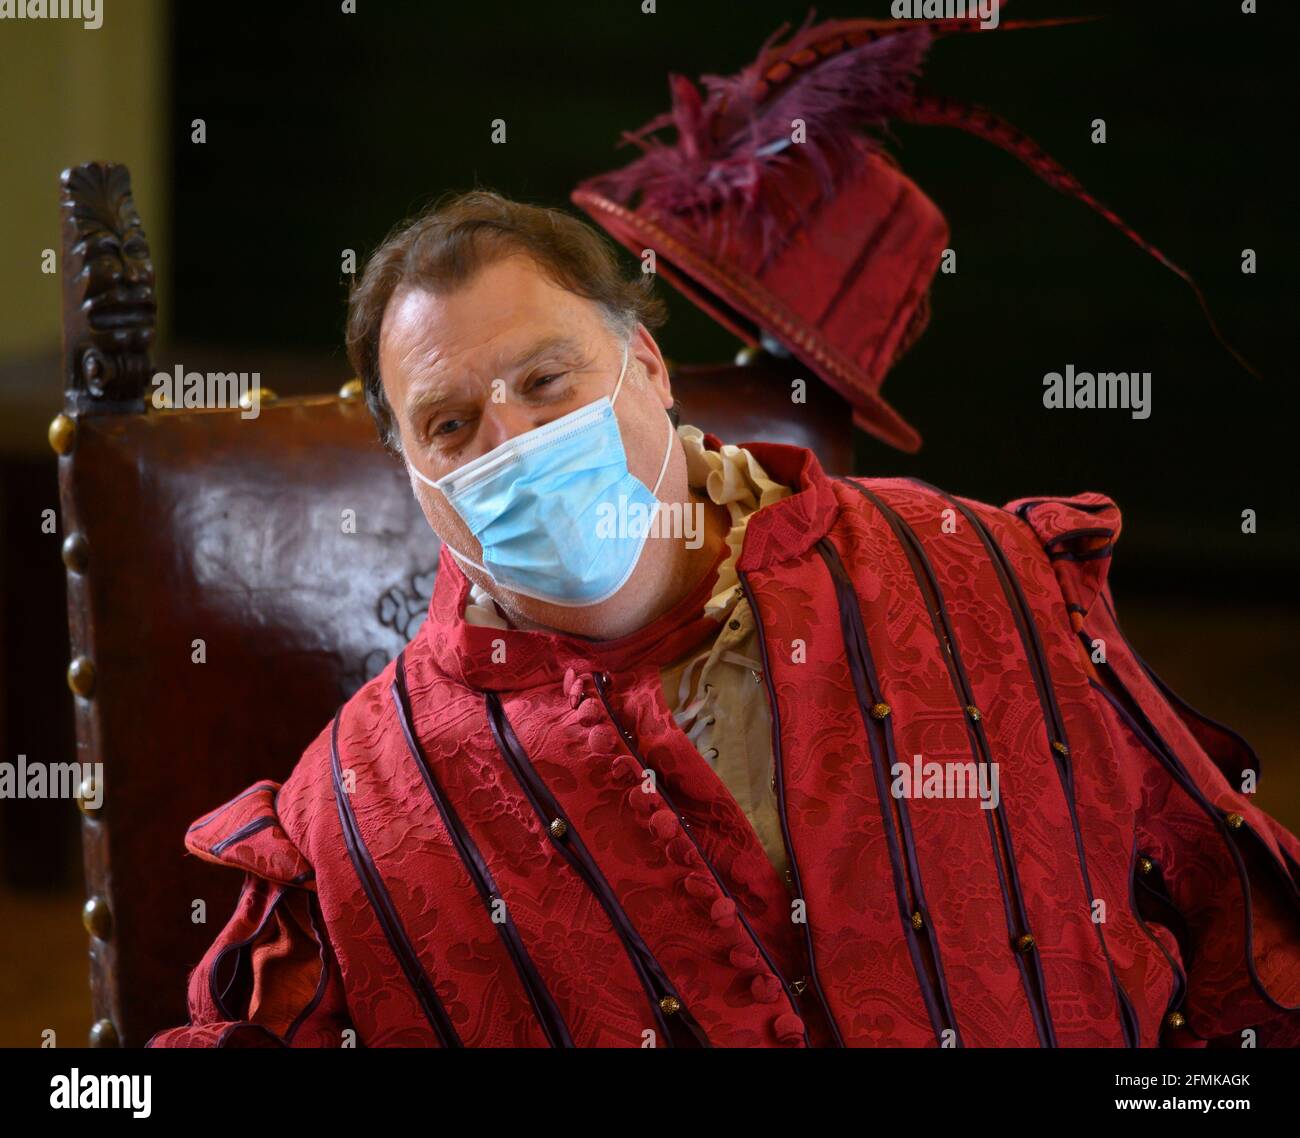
[170,0,1300,601]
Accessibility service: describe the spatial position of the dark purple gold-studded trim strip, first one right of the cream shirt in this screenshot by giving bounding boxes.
[816,537,962,1046]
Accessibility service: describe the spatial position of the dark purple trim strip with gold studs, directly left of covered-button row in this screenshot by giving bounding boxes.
[484,692,691,1047]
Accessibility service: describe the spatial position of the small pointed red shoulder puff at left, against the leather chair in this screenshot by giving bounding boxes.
[185,779,316,890]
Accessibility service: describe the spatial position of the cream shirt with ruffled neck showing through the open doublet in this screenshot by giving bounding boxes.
[464,424,792,880]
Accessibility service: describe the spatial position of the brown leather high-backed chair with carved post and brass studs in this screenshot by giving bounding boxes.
[51,163,850,1047]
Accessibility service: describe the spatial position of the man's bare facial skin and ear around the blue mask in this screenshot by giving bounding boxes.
[380,255,685,624]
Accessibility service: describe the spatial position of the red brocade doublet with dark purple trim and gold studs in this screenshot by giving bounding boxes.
[151,440,1300,1047]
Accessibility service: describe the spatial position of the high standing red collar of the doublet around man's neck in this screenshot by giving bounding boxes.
[417,434,839,691]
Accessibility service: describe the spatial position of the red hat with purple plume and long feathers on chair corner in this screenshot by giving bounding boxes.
[572,12,1244,451]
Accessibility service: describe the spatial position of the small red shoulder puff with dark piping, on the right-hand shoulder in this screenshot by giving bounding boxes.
[1002,492,1122,616]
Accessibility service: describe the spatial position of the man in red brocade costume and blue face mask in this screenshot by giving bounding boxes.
[151,192,1300,1047]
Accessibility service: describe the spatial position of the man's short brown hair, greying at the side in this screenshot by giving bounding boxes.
[347,190,676,451]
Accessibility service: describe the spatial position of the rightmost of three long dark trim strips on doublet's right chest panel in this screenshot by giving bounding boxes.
[913,479,1139,1047]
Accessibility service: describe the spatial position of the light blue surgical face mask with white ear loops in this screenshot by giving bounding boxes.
[407,335,673,607]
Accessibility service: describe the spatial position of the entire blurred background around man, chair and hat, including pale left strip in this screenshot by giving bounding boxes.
[0,0,1300,1043]
